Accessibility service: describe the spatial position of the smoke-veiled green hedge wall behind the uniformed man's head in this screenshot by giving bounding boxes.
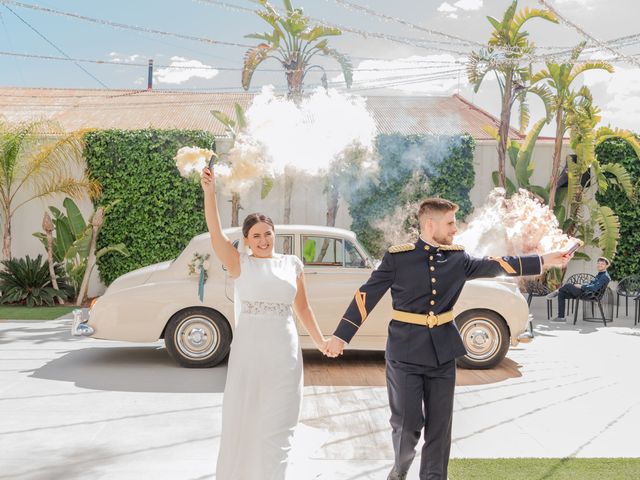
[349,134,475,258]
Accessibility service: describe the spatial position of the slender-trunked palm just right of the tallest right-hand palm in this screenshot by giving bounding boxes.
[531,42,613,210]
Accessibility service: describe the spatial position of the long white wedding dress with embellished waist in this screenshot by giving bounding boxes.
[216,253,303,480]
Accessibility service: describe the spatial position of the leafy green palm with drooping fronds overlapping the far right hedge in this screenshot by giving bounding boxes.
[556,91,640,258]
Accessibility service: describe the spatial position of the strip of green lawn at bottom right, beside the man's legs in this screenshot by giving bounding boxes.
[449,458,640,480]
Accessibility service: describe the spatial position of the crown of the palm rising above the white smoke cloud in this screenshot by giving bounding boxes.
[242,0,353,99]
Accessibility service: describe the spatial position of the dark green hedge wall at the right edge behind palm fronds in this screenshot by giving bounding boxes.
[596,139,640,280]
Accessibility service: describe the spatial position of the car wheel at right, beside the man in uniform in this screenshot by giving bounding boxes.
[456,310,509,369]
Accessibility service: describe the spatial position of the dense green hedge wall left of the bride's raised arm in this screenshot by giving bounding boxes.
[84,130,215,285]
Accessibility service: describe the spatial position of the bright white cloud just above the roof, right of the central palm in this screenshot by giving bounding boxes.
[332,54,467,95]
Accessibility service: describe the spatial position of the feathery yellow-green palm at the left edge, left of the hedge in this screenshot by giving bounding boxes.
[0,121,100,260]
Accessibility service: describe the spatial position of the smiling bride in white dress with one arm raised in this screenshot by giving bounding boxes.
[201,168,328,480]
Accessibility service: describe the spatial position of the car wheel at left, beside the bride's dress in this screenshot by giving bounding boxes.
[164,307,232,368]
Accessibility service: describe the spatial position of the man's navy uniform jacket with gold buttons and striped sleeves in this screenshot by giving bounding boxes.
[334,239,542,366]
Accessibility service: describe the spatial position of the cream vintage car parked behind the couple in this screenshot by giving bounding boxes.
[72,225,531,369]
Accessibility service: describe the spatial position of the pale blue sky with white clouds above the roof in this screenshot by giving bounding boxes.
[0,0,640,135]
